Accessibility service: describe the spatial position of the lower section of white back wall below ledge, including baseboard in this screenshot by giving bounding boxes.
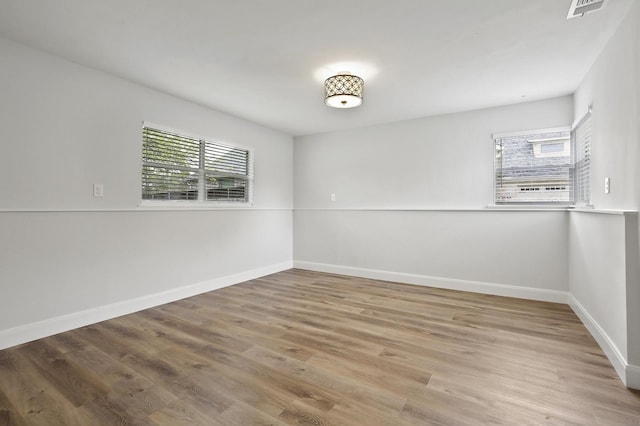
[294,210,568,302]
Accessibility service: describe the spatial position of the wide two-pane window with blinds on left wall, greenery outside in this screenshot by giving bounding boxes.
[142,126,253,203]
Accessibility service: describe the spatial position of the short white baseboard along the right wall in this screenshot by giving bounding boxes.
[569,295,640,389]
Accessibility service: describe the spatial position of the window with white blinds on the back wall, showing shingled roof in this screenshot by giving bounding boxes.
[494,128,573,204]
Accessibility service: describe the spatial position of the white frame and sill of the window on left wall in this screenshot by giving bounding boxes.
[138,121,254,209]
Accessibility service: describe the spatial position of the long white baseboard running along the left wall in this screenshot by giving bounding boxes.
[0,262,293,349]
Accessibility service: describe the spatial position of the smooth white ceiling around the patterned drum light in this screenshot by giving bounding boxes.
[0,0,634,135]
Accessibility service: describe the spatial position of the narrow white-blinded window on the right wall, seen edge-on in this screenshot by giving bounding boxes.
[571,111,591,205]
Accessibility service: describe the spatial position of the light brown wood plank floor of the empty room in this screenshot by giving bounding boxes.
[0,270,640,426]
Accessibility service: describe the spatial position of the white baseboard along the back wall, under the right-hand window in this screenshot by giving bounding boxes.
[293,260,569,304]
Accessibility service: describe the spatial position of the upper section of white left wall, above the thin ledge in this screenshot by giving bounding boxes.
[0,39,293,210]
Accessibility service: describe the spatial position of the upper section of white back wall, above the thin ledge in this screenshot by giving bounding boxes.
[294,96,573,209]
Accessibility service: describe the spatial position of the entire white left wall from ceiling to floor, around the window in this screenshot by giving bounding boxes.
[0,39,293,348]
